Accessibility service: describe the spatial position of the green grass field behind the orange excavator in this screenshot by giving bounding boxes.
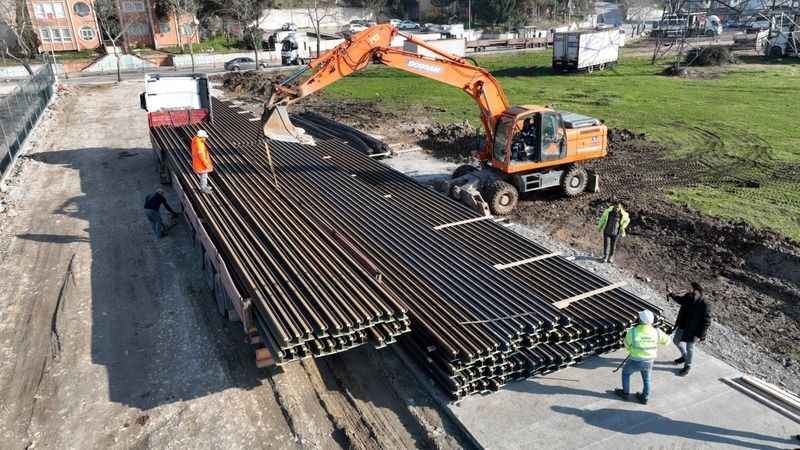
[327,52,800,240]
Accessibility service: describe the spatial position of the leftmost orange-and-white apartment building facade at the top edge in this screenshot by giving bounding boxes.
[28,0,101,52]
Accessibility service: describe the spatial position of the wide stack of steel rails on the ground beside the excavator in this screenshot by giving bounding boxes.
[153,101,660,398]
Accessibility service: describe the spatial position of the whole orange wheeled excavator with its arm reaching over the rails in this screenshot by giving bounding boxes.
[262,24,608,215]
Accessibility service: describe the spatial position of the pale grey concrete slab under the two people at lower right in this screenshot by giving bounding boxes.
[450,348,800,450]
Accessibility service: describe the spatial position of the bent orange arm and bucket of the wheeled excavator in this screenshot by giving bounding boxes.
[264,24,509,148]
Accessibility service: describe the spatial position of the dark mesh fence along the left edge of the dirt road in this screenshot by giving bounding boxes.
[0,64,55,179]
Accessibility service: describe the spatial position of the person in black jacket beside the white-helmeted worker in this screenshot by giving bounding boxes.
[667,283,711,376]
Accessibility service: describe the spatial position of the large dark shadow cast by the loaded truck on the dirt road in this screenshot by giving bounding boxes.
[24,148,264,410]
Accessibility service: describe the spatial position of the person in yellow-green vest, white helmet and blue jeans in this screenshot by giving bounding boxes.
[614,309,670,405]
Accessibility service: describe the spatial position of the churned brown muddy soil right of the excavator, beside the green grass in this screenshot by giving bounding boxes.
[513,131,800,373]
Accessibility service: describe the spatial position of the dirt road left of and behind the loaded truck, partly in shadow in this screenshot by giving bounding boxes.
[0,82,470,449]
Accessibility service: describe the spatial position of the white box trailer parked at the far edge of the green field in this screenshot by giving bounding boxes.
[553,28,622,72]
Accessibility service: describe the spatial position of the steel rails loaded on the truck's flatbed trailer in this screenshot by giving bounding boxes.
[151,106,409,364]
